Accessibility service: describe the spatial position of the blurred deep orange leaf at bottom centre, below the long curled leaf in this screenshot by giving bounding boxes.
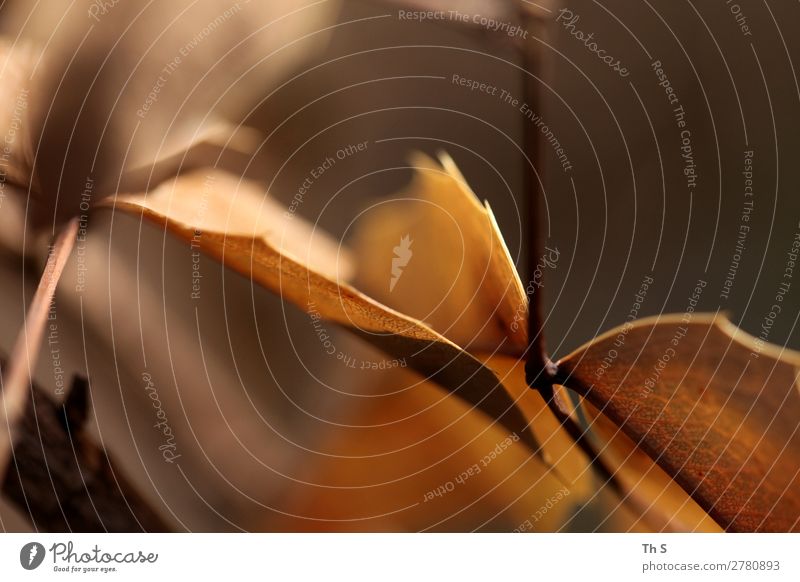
[279,369,580,531]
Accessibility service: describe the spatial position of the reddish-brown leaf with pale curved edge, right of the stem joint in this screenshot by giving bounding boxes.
[558,315,800,531]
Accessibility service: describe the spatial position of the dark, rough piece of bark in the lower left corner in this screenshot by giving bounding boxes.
[2,377,170,532]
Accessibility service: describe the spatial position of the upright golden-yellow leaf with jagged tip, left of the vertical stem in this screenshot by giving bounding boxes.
[353,154,528,353]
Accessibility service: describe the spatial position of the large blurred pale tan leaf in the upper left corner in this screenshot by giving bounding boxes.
[3,0,339,225]
